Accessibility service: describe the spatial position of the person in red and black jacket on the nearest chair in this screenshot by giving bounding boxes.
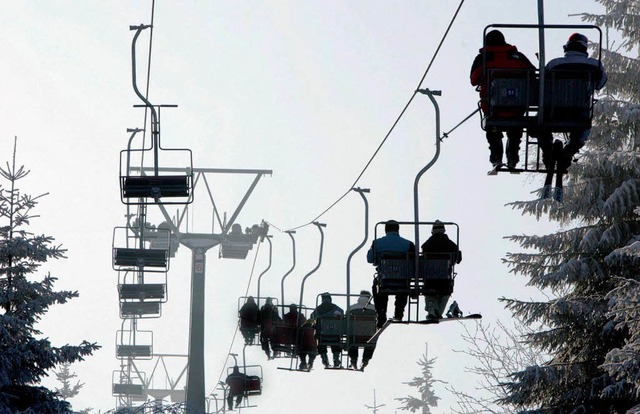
[470,30,535,169]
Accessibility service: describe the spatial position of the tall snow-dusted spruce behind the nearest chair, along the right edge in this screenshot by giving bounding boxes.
[502,0,640,414]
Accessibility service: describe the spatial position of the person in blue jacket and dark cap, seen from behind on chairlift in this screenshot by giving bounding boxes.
[367,220,415,328]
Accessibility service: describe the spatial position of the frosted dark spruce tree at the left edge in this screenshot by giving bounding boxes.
[0,140,99,414]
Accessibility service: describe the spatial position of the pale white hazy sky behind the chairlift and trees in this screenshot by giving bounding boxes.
[0,0,595,414]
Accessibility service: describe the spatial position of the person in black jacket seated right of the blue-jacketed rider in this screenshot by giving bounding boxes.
[421,220,462,319]
